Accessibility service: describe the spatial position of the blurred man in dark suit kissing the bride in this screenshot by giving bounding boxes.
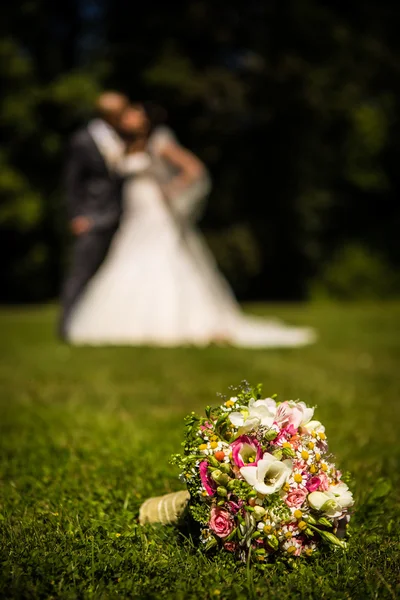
[60,92,129,339]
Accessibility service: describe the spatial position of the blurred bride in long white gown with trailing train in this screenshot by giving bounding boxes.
[68,108,315,348]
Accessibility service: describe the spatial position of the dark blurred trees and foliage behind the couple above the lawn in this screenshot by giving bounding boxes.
[0,0,400,302]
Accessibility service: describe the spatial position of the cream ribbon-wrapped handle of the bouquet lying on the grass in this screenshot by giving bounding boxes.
[139,490,190,525]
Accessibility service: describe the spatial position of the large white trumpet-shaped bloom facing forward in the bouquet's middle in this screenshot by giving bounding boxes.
[240,452,293,495]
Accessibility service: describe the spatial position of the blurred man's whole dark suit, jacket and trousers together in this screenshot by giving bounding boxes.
[60,124,122,337]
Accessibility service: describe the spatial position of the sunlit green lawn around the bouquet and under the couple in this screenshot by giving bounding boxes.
[0,304,400,600]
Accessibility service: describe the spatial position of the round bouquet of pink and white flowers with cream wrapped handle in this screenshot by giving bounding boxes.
[141,384,353,563]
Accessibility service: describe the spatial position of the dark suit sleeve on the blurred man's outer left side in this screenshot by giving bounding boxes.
[64,137,86,219]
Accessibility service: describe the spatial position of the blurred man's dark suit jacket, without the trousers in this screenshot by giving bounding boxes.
[65,128,122,230]
